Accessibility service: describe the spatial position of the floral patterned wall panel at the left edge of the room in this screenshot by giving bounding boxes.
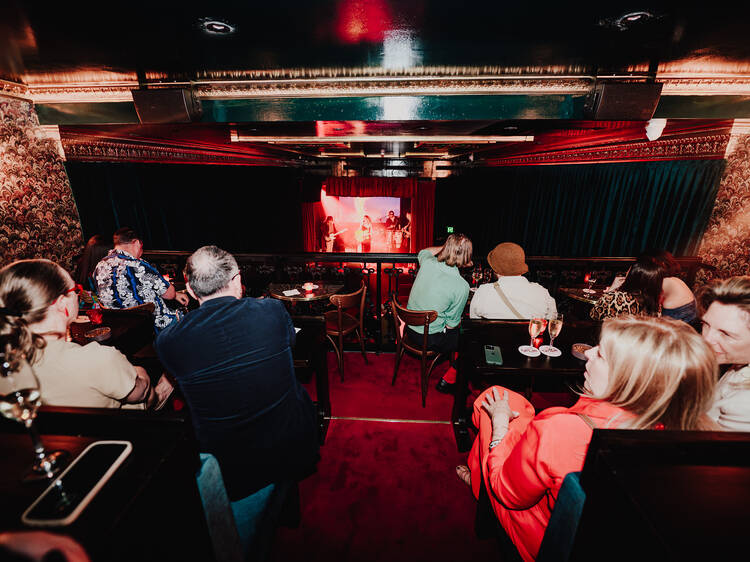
[0,96,83,270]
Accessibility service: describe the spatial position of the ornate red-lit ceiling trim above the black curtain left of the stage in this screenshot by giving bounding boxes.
[63,139,297,166]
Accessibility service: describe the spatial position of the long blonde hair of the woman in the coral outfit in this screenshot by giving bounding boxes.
[584,316,719,430]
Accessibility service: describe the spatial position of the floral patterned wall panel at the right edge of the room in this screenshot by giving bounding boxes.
[696,135,750,286]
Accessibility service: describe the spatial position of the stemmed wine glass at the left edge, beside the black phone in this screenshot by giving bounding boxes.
[0,352,70,480]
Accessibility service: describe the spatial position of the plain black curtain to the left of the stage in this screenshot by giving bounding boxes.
[66,162,303,253]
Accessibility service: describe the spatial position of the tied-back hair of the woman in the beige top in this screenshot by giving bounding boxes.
[0,259,70,366]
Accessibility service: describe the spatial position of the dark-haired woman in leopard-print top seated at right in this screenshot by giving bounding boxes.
[589,260,664,320]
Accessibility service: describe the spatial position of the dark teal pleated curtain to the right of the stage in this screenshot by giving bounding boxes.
[435,160,725,257]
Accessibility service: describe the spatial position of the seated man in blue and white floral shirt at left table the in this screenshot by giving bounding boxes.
[94,227,189,332]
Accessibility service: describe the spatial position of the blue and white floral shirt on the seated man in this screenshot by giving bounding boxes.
[94,250,180,332]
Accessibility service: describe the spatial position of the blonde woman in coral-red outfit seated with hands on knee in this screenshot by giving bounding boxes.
[456,317,718,560]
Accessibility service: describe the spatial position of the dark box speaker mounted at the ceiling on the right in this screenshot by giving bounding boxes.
[584,82,662,121]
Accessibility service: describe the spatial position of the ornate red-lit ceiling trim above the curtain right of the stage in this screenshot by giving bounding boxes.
[485,134,730,166]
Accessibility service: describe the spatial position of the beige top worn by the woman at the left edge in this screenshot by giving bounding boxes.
[33,339,137,408]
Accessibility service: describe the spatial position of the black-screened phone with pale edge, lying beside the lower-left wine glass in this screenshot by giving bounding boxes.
[21,441,133,527]
